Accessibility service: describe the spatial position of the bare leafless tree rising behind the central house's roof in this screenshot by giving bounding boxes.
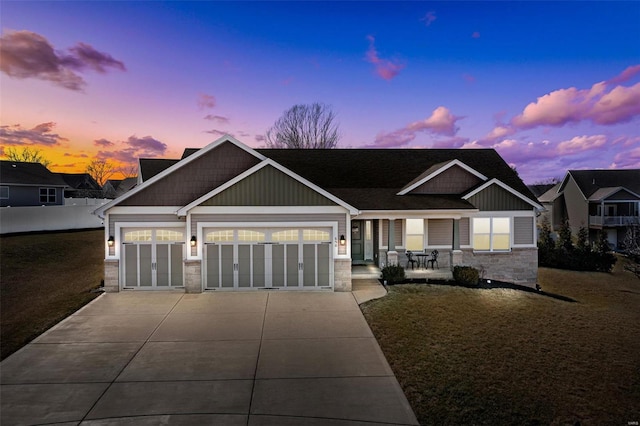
[265,102,340,149]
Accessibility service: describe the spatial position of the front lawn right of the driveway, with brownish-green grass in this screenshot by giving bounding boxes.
[363,260,640,425]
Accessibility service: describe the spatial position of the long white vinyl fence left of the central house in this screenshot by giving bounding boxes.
[0,198,111,234]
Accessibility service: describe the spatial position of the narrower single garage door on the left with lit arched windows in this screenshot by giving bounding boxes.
[121,229,184,289]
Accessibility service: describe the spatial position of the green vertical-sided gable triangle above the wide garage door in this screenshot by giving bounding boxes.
[201,166,335,206]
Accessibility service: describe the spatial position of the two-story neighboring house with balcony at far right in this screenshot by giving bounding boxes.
[540,169,640,248]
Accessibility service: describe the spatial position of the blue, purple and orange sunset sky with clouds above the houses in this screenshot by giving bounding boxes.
[0,1,640,183]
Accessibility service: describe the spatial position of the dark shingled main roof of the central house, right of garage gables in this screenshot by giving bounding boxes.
[256,149,536,210]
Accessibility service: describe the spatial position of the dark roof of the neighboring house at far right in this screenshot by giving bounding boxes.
[563,169,640,199]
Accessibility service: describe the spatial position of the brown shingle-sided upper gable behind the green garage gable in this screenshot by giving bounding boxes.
[119,142,259,206]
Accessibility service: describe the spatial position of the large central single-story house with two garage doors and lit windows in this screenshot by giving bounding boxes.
[95,136,542,292]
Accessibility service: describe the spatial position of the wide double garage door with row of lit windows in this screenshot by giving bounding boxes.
[204,228,333,290]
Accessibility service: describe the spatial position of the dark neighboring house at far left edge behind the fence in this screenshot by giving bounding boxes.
[0,160,67,207]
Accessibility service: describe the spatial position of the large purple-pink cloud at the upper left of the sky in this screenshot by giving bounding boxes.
[0,31,126,91]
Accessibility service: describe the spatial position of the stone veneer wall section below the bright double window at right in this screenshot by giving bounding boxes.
[462,247,538,288]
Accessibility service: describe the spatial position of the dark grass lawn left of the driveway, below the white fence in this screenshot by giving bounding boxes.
[0,230,104,359]
